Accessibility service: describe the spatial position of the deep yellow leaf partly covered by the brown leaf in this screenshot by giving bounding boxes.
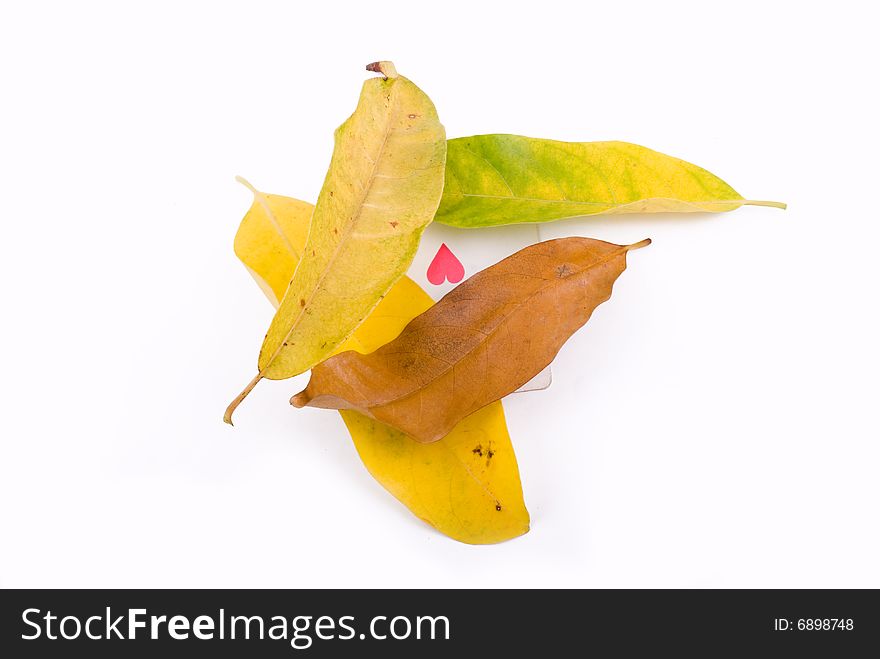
[235,181,529,544]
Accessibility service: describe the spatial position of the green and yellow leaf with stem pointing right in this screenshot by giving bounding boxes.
[435,135,785,228]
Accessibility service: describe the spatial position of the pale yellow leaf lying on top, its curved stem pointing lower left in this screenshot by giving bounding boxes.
[224,62,446,423]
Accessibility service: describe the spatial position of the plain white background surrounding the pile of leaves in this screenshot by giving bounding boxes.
[0,0,880,587]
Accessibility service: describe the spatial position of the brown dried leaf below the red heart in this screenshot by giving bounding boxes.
[290,237,650,443]
